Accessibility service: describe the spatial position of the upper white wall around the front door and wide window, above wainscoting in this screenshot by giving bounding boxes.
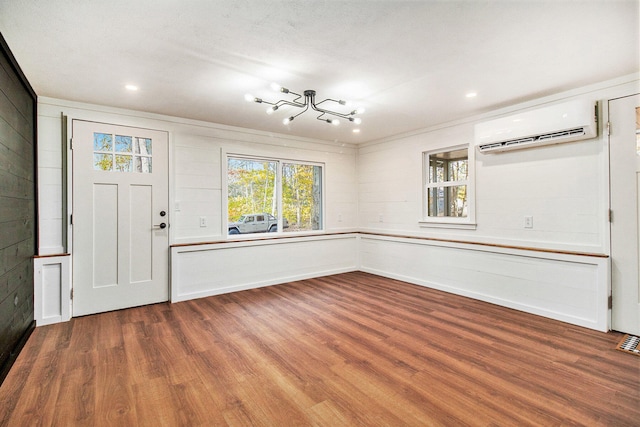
[38,98,357,255]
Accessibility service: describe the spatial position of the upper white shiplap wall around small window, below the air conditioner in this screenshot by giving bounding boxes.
[358,99,608,253]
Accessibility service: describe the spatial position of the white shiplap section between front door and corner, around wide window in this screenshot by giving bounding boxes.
[172,133,357,243]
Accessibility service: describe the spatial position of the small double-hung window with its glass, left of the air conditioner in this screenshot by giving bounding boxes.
[423,146,475,229]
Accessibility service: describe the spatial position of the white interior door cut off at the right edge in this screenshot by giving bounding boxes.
[609,95,640,335]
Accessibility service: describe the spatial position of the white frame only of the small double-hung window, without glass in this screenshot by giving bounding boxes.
[419,144,477,230]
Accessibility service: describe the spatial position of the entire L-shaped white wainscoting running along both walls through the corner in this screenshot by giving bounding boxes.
[171,233,610,331]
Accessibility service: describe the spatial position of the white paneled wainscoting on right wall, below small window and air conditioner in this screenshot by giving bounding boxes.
[359,234,610,332]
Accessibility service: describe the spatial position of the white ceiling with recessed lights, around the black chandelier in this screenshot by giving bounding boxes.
[0,0,640,144]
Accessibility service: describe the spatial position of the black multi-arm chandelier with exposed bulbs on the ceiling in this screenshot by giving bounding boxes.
[244,85,364,126]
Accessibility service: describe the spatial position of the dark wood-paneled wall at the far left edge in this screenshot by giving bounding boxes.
[0,34,37,383]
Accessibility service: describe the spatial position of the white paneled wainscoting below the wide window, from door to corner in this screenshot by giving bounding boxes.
[171,233,358,302]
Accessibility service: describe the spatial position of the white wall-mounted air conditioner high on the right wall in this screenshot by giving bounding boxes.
[475,100,598,153]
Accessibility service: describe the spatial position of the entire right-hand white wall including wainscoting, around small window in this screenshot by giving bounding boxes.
[358,76,639,330]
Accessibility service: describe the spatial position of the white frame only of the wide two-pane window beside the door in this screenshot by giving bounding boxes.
[220,150,327,240]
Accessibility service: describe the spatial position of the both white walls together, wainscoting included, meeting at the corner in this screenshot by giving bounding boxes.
[36,76,638,330]
